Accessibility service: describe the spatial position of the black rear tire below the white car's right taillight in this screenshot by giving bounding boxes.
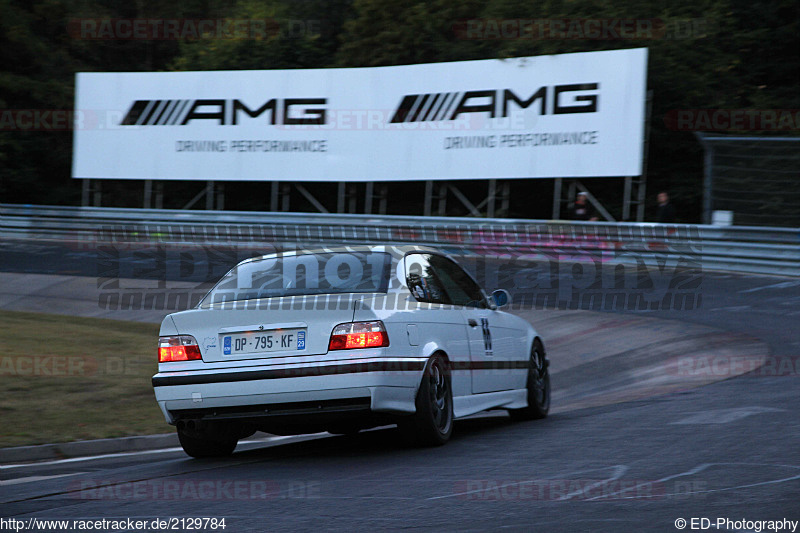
[398,354,453,446]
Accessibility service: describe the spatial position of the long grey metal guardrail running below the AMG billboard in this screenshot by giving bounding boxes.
[0,204,800,276]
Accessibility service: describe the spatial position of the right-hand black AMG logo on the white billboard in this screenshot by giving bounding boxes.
[391,83,600,123]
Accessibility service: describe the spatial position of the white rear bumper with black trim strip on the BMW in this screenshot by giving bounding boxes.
[153,358,427,424]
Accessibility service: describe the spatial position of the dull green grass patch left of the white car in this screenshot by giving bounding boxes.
[0,311,167,447]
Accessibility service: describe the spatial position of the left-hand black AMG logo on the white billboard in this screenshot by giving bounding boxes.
[120,98,328,126]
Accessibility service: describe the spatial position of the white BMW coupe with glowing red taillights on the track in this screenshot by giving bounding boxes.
[153,246,550,457]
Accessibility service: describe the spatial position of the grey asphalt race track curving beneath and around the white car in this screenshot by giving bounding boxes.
[0,239,800,532]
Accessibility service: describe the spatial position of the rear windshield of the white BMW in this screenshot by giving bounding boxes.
[200,252,392,307]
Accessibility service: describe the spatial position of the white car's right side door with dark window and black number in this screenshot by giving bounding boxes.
[430,255,527,394]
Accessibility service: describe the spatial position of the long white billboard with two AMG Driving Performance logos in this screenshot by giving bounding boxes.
[73,48,647,181]
